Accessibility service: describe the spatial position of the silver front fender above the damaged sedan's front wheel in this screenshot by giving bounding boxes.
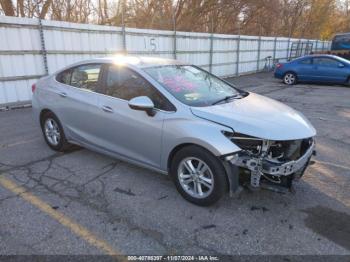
[161,118,241,170]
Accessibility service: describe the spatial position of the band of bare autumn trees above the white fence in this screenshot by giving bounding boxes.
[0,0,350,38]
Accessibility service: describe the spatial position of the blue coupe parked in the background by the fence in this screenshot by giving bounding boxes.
[275,55,350,85]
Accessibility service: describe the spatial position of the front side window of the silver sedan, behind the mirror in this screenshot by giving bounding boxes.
[105,65,175,111]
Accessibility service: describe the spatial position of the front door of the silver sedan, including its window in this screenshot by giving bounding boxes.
[94,65,174,168]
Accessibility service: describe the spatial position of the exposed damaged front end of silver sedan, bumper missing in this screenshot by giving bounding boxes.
[224,132,315,192]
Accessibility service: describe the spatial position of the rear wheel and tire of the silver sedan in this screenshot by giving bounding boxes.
[40,111,72,152]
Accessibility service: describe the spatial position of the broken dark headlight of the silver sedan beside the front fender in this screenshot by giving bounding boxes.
[223,131,263,155]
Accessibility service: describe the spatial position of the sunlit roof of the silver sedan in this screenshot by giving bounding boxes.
[75,55,188,68]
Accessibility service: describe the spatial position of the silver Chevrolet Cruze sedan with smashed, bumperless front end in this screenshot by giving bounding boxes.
[32,56,316,205]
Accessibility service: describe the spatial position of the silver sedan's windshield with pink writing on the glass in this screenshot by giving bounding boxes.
[144,65,240,106]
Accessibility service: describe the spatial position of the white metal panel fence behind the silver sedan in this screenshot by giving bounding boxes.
[0,16,330,106]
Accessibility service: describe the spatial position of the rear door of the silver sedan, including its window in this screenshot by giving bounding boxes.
[56,63,102,144]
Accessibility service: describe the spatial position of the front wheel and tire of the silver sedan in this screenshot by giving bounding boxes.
[170,146,228,206]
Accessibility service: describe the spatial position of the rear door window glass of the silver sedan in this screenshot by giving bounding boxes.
[70,64,101,91]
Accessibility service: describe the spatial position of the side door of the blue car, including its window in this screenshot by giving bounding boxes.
[313,57,348,83]
